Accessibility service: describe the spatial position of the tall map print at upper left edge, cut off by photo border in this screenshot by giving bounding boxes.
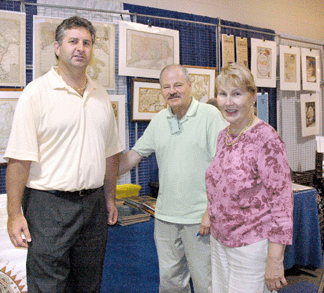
[0,11,26,87]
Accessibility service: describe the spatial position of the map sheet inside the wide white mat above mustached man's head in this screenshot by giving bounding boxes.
[126,29,174,70]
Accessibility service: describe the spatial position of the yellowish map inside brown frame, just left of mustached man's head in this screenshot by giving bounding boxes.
[138,87,167,113]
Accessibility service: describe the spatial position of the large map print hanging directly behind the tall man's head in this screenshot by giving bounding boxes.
[33,15,115,89]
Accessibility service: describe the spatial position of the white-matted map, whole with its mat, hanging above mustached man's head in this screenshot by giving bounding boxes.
[118,21,179,78]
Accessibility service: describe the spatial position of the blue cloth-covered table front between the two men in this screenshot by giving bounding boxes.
[101,217,159,293]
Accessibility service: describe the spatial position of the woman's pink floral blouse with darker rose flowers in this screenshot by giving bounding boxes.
[206,121,293,247]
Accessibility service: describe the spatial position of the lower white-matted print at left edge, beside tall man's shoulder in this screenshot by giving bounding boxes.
[0,99,17,154]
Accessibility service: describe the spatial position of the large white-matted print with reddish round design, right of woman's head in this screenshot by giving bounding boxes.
[251,38,277,88]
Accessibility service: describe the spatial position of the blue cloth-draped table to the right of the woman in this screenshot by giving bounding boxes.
[284,189,323,269]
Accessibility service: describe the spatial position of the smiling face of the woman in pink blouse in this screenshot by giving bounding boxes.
[217,85,255,134]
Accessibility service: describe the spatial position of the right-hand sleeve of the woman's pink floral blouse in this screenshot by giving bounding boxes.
[258,137,293,244]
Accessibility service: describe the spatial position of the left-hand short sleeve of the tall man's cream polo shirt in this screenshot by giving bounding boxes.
[4,92,39,162]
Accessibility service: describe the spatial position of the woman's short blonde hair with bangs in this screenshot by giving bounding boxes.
[216,63,257,96]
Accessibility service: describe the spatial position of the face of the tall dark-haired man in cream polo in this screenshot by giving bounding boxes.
[54,27,93,69]
